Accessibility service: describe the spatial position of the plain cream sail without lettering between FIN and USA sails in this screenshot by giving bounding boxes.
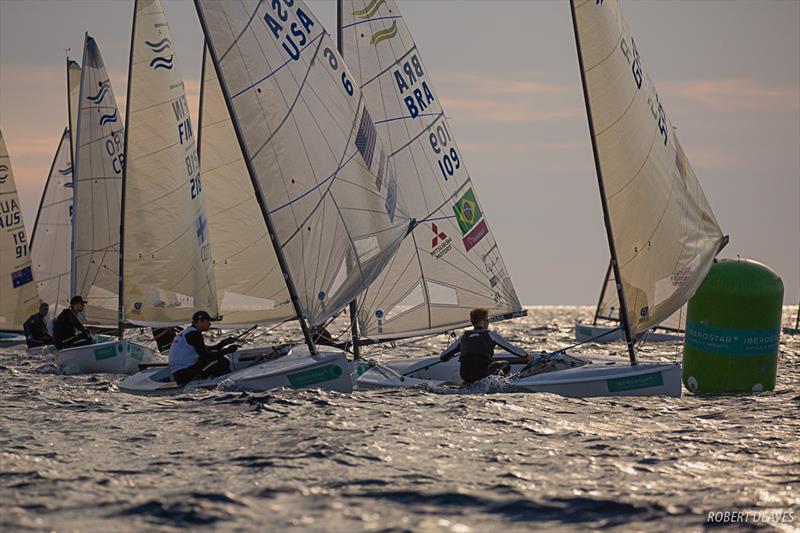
[197,45,295,325]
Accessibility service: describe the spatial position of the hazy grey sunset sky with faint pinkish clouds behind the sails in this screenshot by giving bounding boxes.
[0,0,800,305]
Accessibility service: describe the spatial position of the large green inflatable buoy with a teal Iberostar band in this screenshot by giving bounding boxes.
[683,259,783,393]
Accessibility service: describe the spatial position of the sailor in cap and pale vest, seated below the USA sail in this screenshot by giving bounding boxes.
[169,311,239,385]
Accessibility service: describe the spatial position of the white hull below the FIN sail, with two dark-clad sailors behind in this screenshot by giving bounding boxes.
[56,340,153,374]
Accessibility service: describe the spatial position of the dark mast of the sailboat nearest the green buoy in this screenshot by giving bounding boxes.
[569,0,636,365]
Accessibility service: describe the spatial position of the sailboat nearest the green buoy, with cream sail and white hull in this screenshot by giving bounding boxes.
[359,0,727,397]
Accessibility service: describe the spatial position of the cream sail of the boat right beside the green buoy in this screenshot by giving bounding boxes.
[572,0,725,334]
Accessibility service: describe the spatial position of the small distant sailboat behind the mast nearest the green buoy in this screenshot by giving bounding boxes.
[575,262,686,343]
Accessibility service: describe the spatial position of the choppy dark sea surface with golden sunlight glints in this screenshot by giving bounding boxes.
[0,307,800,532]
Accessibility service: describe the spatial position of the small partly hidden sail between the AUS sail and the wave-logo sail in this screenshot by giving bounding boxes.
[30,128,72,316]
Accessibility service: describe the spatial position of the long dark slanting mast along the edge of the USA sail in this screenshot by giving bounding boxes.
[195,0,318,355]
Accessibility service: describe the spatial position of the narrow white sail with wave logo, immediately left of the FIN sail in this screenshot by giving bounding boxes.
[70,34,125,325]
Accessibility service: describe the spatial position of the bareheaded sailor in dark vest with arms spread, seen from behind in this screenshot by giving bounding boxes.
[439,307,531,383]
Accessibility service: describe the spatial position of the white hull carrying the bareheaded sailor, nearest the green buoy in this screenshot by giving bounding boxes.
[357,355,682,398]
